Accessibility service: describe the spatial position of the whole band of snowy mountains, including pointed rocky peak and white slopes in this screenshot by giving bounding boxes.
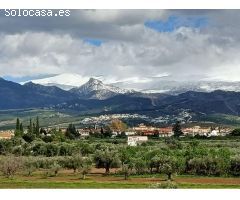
[21,73,240,95]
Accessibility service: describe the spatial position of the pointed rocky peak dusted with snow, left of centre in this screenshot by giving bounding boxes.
[70,78,134,99]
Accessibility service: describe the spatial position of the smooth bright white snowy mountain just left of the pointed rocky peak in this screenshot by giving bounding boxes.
[21,73,89,90]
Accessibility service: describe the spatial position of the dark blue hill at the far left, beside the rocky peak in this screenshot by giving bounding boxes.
[0,79,76,109]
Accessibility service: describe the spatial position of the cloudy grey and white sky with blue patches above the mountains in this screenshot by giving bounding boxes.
[0,10,240,87]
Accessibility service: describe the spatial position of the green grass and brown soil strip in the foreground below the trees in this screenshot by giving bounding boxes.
[0,170,240,189]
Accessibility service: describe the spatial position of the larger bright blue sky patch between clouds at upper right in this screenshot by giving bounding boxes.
[145,15,208,32]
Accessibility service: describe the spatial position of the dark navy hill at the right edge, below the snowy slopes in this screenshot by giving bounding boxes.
[156,90,240,115]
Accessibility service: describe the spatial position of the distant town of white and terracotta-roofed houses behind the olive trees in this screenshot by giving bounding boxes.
[0,114,233,143]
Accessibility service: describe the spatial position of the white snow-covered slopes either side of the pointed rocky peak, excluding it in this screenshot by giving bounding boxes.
[21,73,240,96]
